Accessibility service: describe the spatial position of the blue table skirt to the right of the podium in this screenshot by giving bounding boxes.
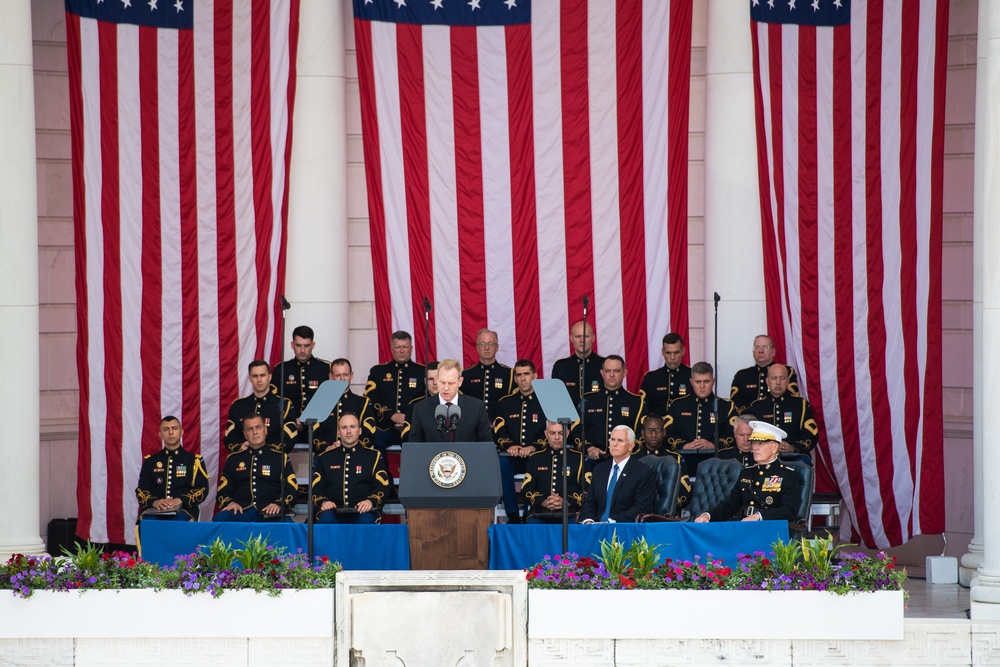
[489,521,788,570]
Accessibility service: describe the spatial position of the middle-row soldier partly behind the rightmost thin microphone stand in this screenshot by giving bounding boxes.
[664,361,736,450]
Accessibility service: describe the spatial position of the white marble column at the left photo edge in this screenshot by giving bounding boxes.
[0,0,45,561]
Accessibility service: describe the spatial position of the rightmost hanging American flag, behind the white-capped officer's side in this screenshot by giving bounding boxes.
[751,0,948,547]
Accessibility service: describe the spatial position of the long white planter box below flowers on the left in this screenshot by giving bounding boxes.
[0,588,334,639]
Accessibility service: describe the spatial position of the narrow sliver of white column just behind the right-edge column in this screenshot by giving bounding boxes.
[958,1,989,586]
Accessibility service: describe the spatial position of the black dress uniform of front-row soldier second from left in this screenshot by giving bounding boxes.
[218,445,299,514]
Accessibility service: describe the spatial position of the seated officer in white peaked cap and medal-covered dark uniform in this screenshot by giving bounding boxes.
[695,421,802,523]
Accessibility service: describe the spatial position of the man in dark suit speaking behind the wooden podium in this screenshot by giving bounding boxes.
[410,359,493,444]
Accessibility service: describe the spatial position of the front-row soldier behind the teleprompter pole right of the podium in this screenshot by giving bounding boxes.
[515,422,590,523]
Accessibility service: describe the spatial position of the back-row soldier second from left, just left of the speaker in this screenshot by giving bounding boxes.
[365,331,427,452]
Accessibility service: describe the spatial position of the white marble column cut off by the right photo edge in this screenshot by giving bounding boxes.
[969,0,1000,620]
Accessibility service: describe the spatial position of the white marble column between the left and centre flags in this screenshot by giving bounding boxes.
[283,0,351,360]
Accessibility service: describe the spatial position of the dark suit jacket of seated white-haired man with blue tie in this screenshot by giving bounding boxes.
[577,455,656,523]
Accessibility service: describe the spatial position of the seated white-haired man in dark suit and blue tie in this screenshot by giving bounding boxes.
[578,426,656,523]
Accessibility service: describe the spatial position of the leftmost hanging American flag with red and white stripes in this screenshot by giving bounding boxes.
[66,0,298,543]
